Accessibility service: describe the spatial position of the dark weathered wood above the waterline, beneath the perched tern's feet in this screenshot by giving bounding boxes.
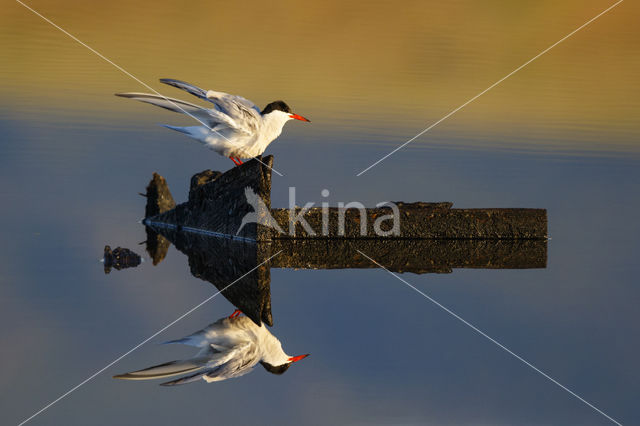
[145,156,547,241]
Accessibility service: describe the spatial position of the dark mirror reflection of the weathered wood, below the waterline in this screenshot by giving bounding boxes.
[149,227,547,325]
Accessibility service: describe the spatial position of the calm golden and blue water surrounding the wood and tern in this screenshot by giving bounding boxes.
[0,0,640,425]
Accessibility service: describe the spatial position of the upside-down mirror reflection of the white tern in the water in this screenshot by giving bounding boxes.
[113,310,309,386]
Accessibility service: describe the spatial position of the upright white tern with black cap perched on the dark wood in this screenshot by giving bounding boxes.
[116,78,310,165]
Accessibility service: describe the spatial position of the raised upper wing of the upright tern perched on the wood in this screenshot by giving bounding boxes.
[160,78,262,134]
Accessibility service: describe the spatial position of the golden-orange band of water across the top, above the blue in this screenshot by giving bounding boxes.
[0,0,640,152]
